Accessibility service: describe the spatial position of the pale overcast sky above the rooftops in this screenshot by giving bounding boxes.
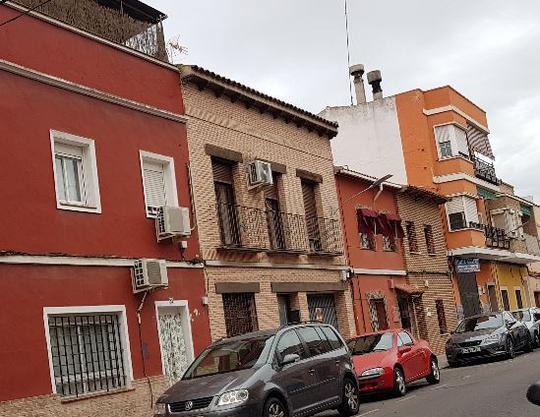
[153,0,540,201]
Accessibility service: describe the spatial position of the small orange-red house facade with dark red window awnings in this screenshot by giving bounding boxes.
[336,168,410,334]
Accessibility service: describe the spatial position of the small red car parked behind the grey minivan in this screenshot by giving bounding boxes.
[347,329,441,396]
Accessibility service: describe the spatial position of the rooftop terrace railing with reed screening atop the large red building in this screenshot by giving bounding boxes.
[17,0,167,61]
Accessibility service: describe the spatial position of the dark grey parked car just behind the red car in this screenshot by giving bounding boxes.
[446,311,533,366]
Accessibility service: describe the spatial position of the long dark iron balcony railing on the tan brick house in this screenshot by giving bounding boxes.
[216,203,343,255]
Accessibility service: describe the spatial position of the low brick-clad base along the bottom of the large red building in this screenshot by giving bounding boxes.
[0,377,169,417]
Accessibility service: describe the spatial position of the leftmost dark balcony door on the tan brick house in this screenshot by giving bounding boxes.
[212,160,240,246]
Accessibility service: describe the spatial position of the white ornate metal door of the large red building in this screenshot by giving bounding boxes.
[158,309,189,385]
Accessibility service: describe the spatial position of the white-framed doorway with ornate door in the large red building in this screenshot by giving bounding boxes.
[156,301,194,385]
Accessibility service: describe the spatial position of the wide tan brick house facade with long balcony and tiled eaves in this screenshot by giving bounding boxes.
[181,66,354,340]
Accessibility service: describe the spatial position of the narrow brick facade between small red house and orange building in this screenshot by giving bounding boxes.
[396,187,457,354]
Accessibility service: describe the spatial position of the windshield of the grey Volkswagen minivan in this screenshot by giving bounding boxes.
[183,335,274,379]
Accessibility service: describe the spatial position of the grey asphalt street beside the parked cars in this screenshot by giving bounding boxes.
[327,349,540,417]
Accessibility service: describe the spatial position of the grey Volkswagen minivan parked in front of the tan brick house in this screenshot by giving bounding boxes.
[155,324,359,417]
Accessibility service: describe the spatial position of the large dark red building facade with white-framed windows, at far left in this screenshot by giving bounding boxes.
[0,5,210,416]
